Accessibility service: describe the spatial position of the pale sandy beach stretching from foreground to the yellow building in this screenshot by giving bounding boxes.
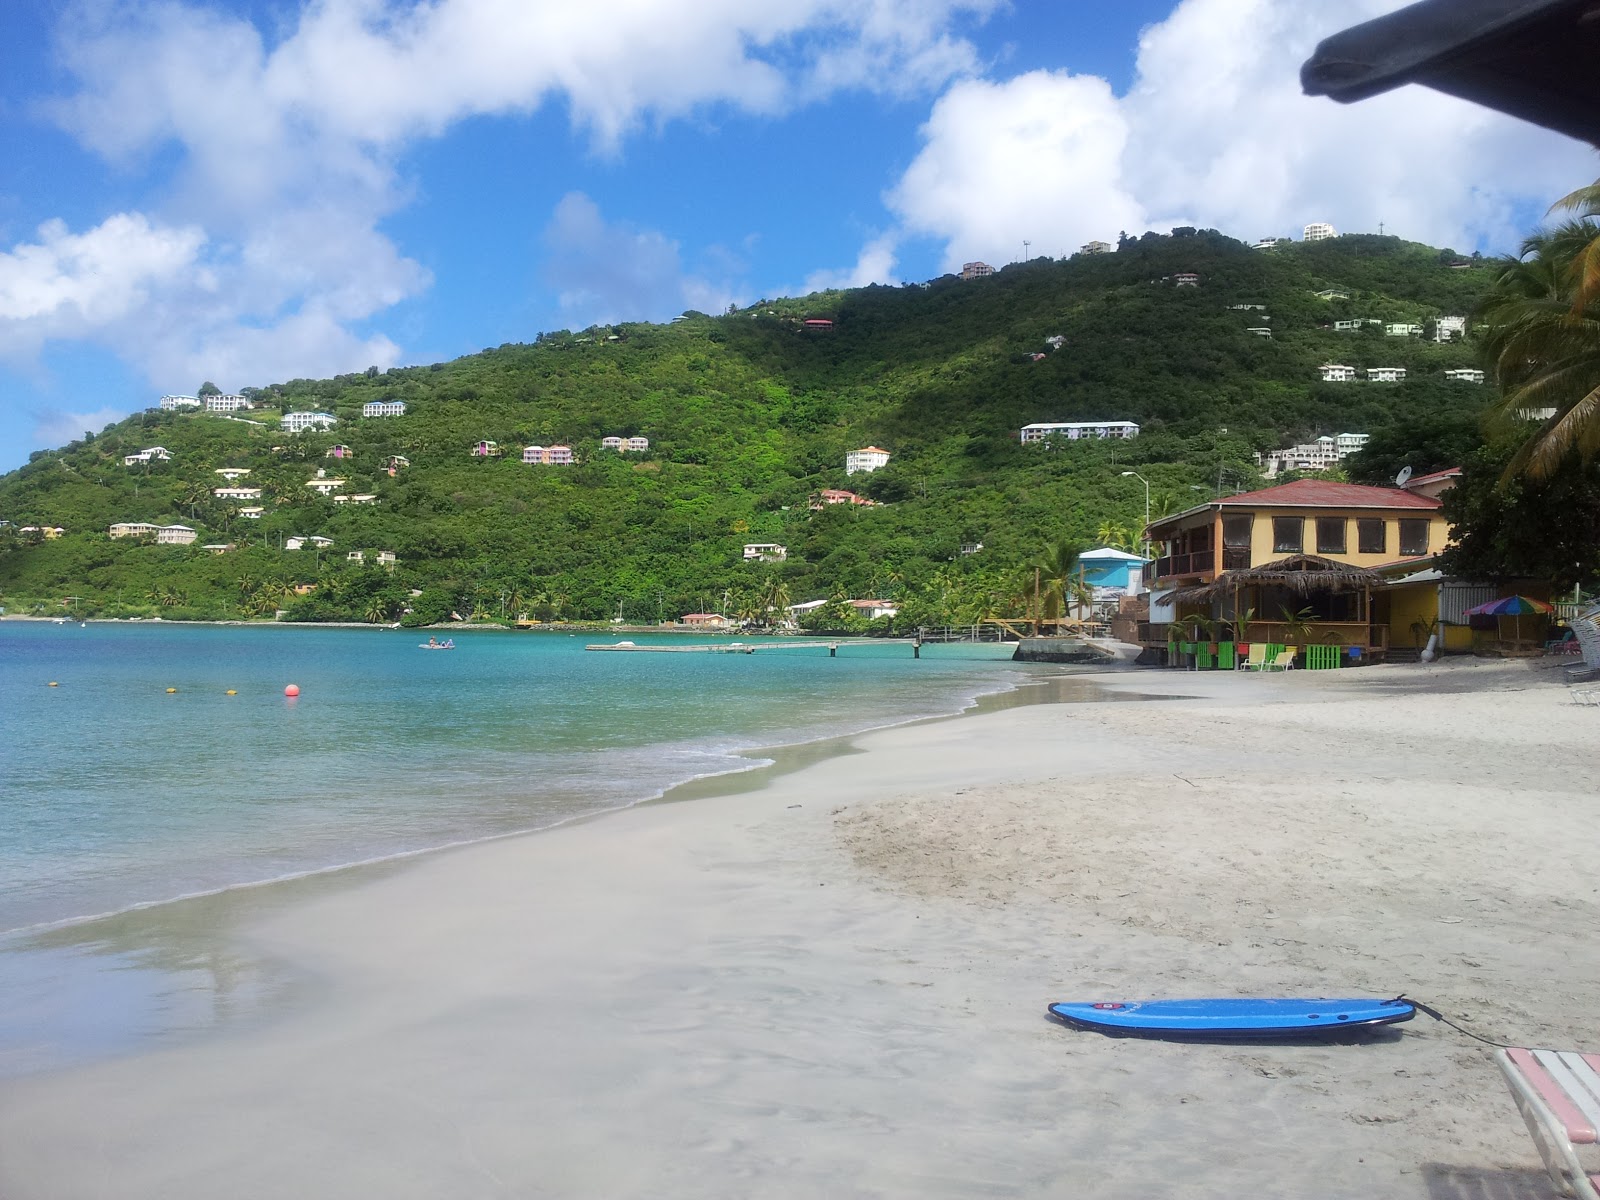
[0,661,1600,1200]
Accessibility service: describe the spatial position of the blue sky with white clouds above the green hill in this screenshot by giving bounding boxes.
[0,0,1600,470]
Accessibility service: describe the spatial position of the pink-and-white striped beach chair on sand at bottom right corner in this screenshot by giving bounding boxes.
[1494,1050,1600,1200]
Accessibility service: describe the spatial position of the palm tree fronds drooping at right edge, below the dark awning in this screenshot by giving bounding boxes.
[1478,220,1600,478]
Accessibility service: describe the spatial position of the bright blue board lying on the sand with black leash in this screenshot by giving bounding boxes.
[1050,997,1416,1037]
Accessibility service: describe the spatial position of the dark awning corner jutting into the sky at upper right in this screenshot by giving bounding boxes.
[1301,0,1600,144]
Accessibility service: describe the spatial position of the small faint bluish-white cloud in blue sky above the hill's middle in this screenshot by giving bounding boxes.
[544,192,736,328]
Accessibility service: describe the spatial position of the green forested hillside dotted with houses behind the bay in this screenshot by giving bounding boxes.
[0,230,1491,622]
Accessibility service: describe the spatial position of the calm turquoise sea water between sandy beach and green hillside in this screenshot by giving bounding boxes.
[0,622,1040,933]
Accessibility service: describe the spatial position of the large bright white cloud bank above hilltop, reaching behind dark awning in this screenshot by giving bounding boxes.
[886,0,1594,269]
